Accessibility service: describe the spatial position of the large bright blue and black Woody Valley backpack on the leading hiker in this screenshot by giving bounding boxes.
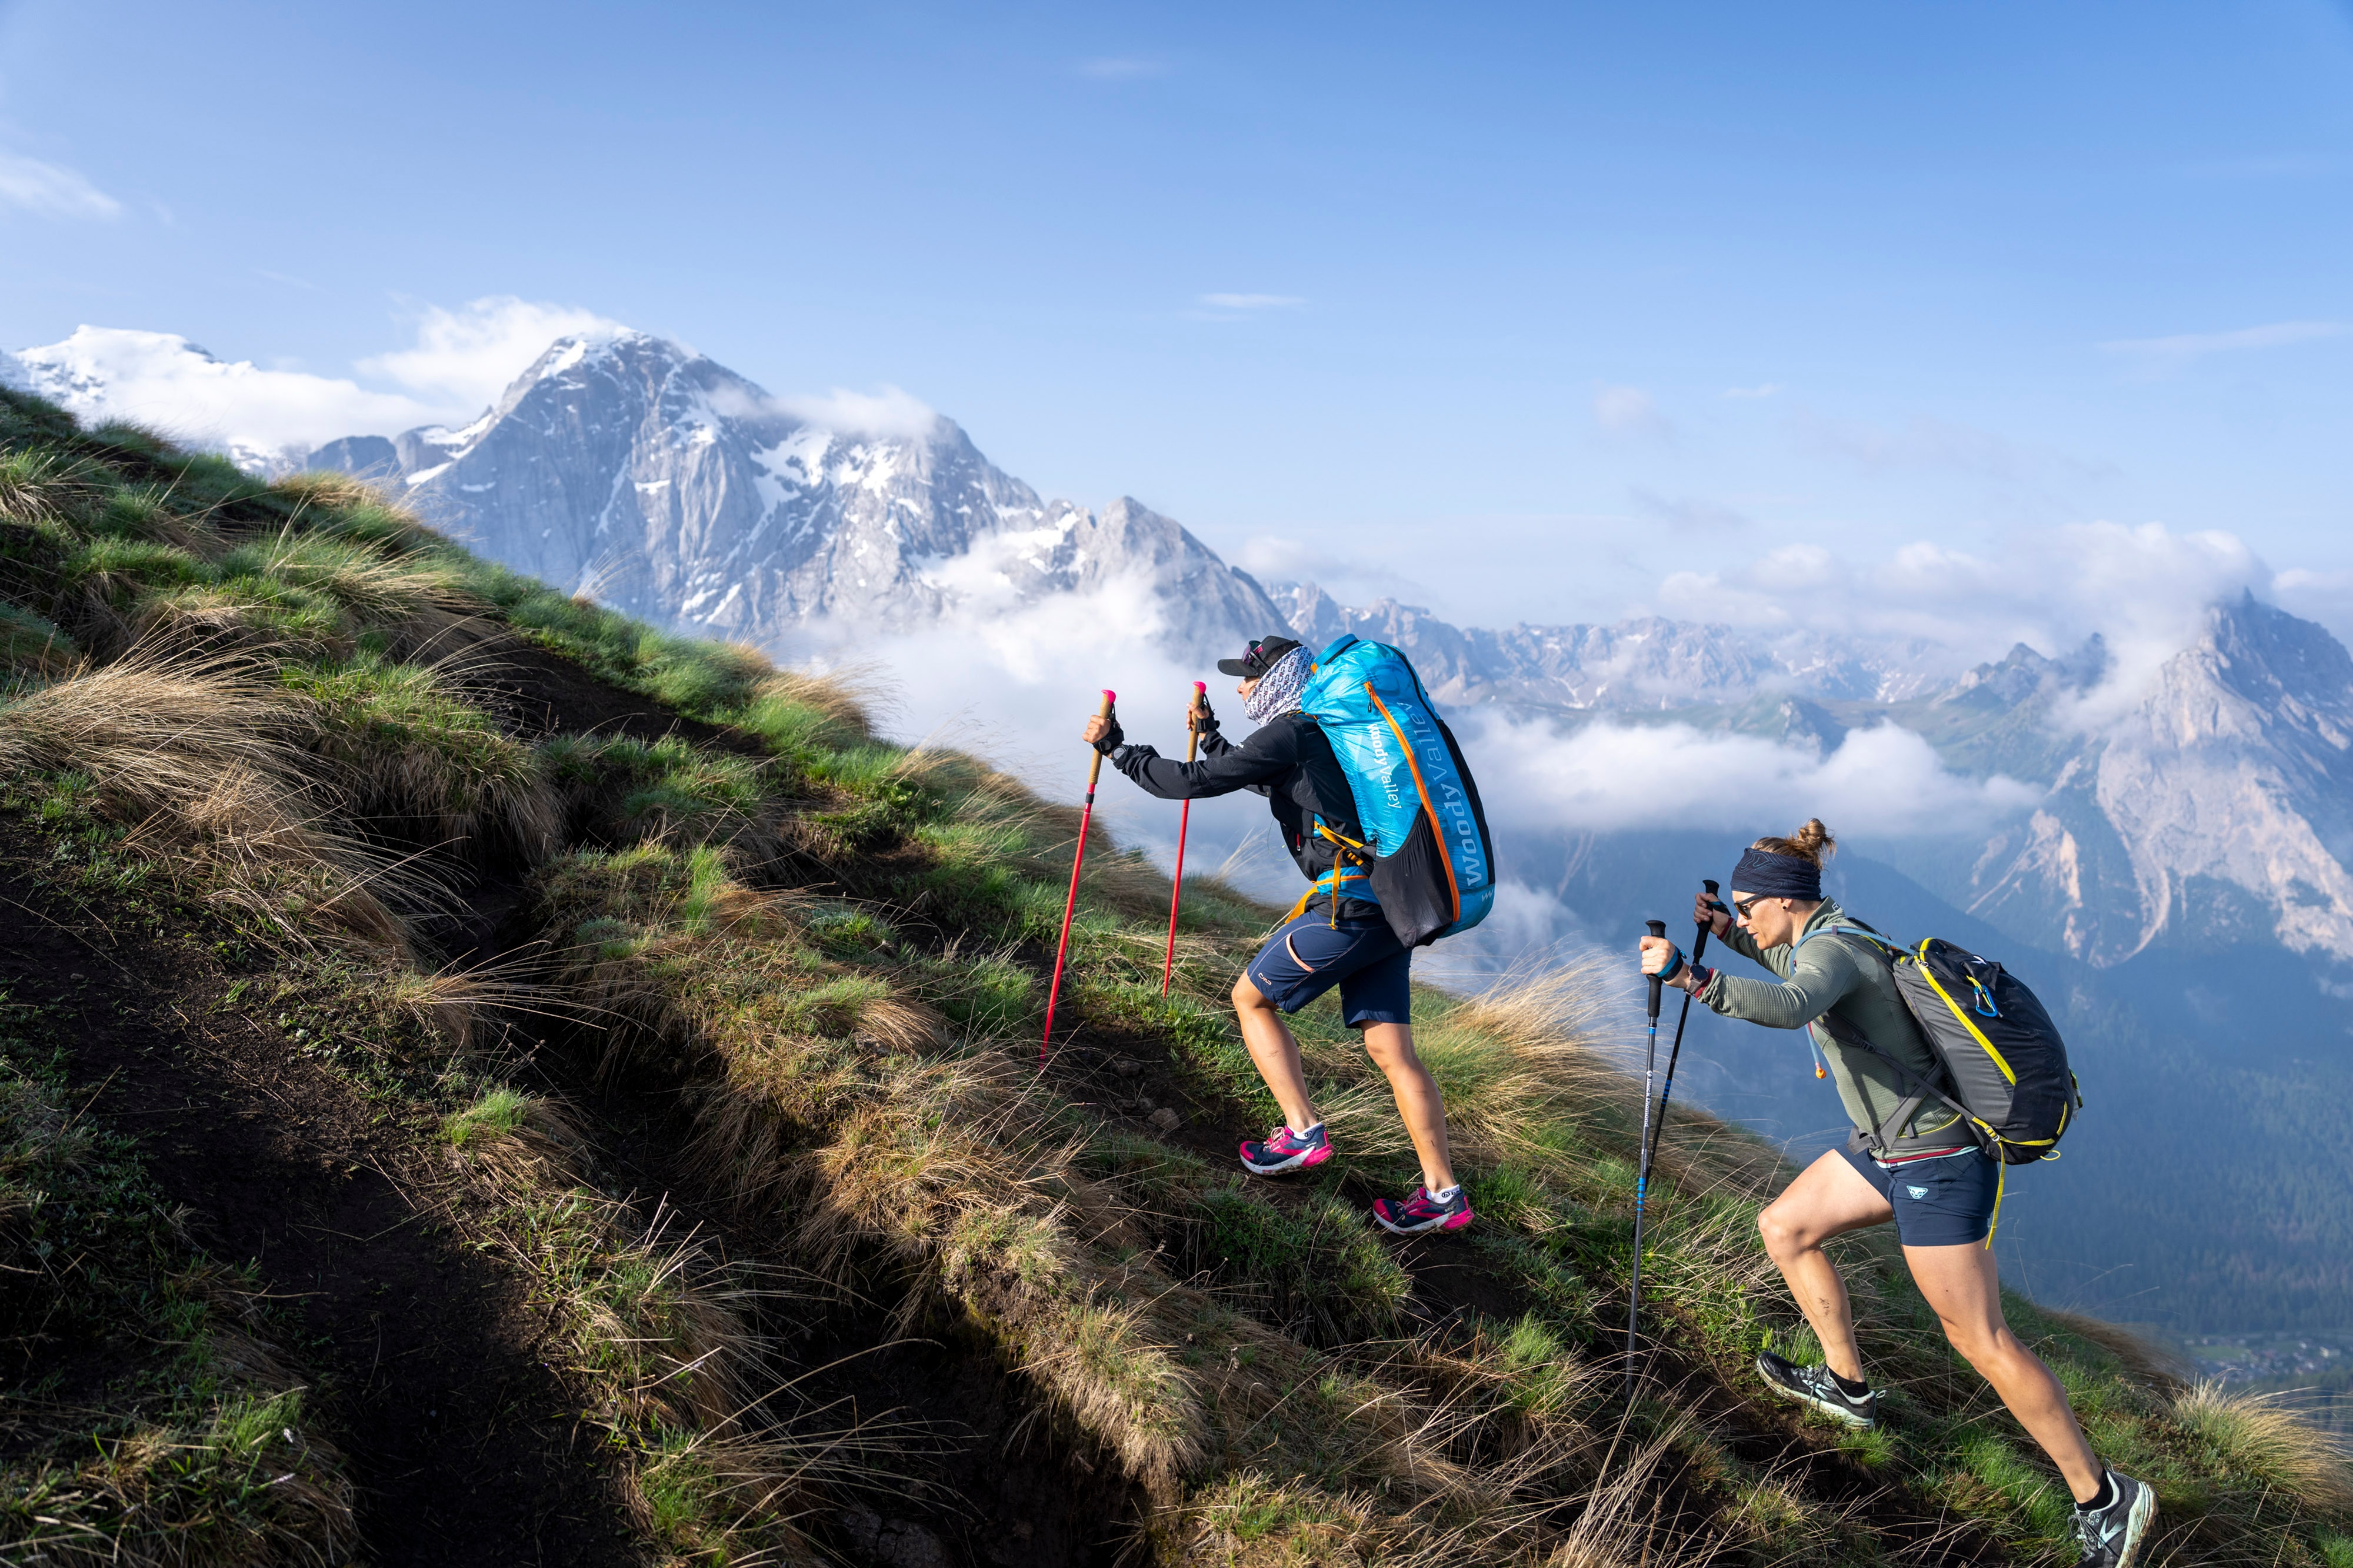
[1299,636,1494,946]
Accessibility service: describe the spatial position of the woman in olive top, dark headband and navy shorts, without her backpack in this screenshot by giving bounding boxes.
[1642,819,2158,1568]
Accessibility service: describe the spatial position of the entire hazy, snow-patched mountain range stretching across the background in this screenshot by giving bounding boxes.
[18,332,2353,1328]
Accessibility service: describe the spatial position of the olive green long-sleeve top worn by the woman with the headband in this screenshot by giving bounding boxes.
[1699,899,1969,1156]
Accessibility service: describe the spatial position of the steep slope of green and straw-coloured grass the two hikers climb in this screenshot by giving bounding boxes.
[0,398,2353,1563]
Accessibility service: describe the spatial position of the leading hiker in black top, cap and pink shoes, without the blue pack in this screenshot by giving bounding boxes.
[1085,636,1475,1236]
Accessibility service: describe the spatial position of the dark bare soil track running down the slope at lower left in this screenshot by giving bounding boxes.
[0,815,640,1568]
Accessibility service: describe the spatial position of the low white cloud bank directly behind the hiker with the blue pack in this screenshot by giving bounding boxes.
[781,582,2040,932]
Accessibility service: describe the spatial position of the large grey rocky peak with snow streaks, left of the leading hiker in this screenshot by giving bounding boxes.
[313,332,1280,648]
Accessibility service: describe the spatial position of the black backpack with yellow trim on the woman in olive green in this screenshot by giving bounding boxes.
[1807,923,2082,1165]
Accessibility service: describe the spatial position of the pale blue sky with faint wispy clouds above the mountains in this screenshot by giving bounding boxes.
[0,0,2353,635]
